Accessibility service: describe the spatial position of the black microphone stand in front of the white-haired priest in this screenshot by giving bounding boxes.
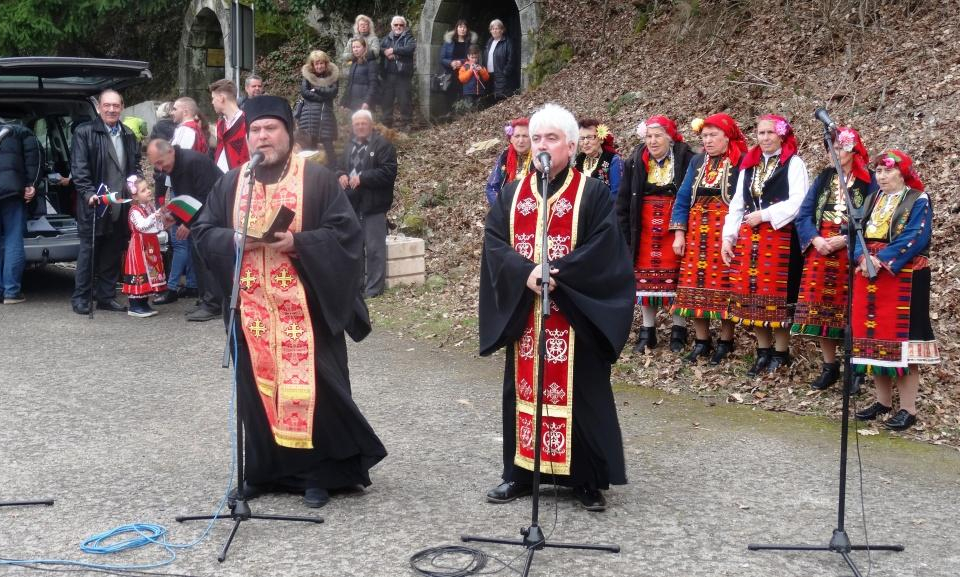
[460,153,620,577]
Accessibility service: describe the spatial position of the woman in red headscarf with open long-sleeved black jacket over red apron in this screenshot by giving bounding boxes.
[617,116,693,353]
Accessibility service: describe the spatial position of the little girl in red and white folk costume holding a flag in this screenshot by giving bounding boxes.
[123,176,167,318]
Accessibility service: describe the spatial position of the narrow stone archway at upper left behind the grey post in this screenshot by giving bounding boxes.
[177,0,233,118]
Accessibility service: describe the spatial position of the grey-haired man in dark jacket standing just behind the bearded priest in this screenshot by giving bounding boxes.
[337,110,397,298]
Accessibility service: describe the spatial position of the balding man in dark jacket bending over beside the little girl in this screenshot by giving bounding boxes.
[147,138,223,321]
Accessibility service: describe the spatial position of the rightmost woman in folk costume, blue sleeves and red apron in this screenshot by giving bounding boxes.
[851,149,940,431]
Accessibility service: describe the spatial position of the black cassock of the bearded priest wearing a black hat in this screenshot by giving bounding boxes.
[191,162,387,489]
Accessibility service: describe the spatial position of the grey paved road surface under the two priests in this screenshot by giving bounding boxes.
[0,268,960,577]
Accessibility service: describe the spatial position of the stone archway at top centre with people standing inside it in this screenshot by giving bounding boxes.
[417,0,540,118]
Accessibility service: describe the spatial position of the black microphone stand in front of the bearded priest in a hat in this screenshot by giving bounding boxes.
[176,155,323,563]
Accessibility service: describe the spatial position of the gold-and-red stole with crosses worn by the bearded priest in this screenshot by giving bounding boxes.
[233,155,316,449]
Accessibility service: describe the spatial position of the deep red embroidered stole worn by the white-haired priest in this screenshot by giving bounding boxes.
[510,168,587,475]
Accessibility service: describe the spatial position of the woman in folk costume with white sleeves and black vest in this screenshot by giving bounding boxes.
[722,114,809,377]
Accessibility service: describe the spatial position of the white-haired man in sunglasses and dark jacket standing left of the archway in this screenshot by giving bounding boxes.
[380,16,417,129]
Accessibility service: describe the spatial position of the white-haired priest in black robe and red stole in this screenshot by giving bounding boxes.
[480,105,635,511]
